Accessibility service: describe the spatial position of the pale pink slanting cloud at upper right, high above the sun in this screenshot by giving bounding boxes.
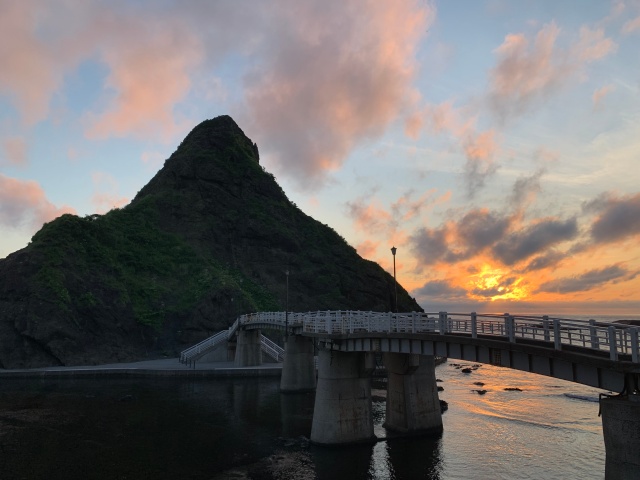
[489,23,616,119]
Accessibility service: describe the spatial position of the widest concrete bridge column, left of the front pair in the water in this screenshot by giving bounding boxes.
[310,349,376,445]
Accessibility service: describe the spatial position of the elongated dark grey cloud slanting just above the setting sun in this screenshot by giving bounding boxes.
[493,218,578,265]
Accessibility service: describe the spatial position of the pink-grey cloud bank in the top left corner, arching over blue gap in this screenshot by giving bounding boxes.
[0,0,201,141]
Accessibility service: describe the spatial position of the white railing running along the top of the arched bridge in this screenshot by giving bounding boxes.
[234,310,640,363]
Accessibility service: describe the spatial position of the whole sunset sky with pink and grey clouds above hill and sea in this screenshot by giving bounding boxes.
[0,0,640,315]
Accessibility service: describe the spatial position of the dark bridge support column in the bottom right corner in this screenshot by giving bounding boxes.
[600,394,640,480]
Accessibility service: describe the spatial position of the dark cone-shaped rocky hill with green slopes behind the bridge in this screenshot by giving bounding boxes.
[0,116,421,368]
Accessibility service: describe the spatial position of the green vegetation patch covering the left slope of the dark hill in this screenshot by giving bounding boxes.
[32,196,280,327]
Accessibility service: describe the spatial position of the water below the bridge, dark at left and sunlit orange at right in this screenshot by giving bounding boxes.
[0,361,605,480]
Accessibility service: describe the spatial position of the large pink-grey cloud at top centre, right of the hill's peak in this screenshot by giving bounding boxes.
[245,0,433,188]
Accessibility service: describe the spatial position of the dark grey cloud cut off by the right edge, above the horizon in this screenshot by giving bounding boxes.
[584,193,640,243]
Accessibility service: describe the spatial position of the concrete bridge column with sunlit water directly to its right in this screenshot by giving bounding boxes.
[383,353,442,435]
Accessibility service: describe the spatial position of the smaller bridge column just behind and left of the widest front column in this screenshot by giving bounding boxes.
[280,335,316,393]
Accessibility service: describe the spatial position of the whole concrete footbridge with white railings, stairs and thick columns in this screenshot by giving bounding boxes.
[180,311,640,479]
